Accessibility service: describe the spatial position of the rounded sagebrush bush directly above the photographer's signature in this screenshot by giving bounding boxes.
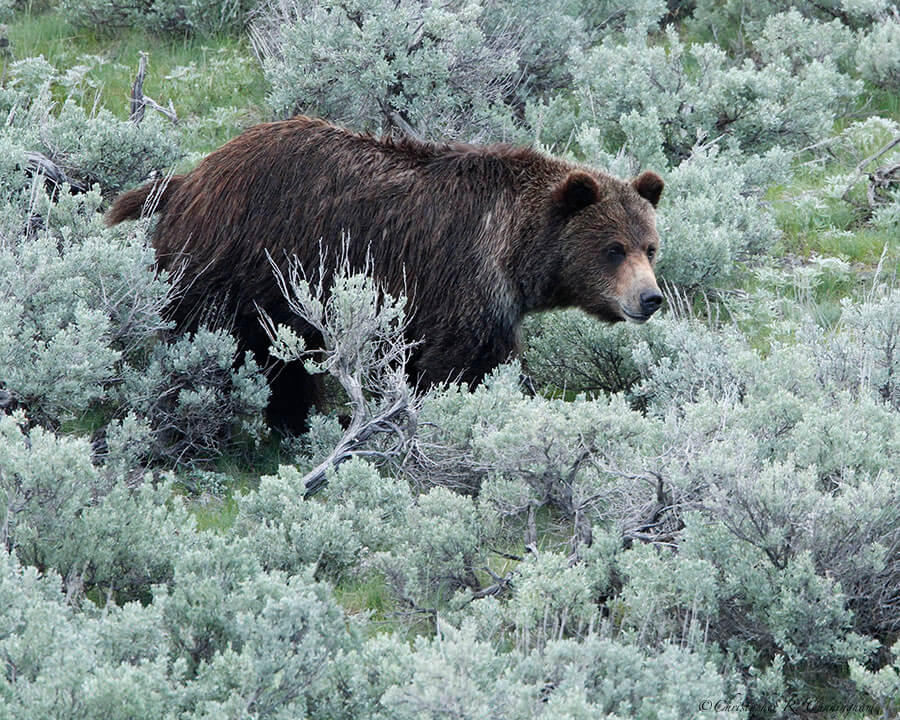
[619,458,896,691]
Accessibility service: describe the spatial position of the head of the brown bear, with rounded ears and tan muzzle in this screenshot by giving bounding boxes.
[552,169,664,323]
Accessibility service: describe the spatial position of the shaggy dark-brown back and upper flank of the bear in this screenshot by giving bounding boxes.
[154,116,541,330]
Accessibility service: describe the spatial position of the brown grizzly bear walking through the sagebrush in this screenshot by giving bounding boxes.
[107,116,663,430]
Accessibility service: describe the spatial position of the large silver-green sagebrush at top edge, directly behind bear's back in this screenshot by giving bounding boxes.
[252,0,665,141]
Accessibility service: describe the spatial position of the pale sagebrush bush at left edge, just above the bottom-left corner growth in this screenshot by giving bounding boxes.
[0,415,191,602]
